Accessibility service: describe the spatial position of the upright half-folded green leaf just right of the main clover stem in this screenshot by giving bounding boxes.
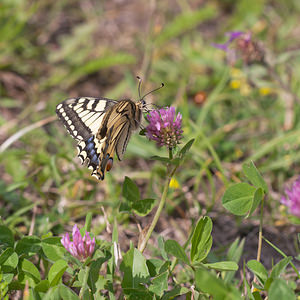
[191,217,212,262]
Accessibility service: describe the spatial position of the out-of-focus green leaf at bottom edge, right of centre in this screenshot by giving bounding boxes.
[195,268,241,300]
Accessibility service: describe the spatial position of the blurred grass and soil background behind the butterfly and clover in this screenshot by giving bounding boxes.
[0,0,300,264]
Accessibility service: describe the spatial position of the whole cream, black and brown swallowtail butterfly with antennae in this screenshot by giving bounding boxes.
[56,77,164,180]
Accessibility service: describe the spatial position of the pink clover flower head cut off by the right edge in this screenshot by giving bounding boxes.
[281,176,300,218]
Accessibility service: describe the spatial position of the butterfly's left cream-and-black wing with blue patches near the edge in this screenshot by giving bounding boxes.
[56,97,118,178]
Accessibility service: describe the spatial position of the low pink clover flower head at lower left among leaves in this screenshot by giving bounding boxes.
[61,224,96,260]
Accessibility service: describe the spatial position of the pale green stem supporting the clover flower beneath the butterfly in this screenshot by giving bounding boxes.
[139,149,178,253]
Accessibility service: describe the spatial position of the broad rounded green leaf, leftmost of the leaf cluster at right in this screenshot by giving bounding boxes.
[222,183,256,216]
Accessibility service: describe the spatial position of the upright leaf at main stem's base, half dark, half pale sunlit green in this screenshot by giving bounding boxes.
[120,248,150,293]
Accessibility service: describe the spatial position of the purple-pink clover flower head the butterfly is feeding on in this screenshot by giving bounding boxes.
[146,107,183,149]
